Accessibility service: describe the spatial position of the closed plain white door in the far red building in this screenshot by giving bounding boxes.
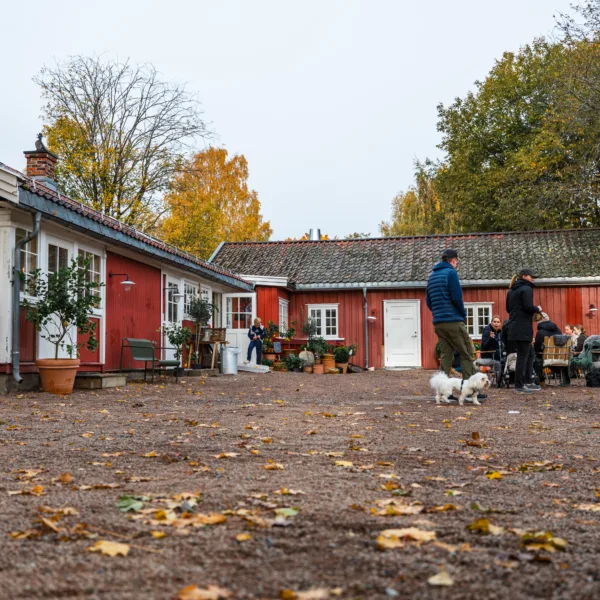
[383,300,421,367]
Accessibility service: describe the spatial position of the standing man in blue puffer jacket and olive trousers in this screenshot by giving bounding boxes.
[425,248,487,400]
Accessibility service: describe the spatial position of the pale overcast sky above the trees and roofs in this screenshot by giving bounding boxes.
[0,0,569,239]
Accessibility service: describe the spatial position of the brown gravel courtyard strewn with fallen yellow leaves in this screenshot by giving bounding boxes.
[0,370,600,600]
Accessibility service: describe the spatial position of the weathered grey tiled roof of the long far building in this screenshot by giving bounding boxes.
[212,229,600,286]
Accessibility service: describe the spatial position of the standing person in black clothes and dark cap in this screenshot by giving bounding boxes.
[506,269,542,394]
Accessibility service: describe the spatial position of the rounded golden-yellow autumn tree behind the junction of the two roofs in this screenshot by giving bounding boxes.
[160,147,273,258]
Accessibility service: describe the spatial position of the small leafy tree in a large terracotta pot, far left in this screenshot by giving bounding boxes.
[23,259,103,394]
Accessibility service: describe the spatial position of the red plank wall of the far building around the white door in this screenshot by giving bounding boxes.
[257,286,600,369]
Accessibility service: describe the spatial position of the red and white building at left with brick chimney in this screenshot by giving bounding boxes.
[0,145,253,390]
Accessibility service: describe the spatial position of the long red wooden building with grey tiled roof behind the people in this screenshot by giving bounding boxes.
[210,229,600,368]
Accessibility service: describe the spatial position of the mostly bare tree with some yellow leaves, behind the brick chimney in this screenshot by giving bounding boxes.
[34,56,209,232]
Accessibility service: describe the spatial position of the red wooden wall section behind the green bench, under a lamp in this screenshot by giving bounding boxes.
[104,252,161,371]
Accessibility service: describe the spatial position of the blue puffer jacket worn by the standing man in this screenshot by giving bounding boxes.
[426,261,467,325]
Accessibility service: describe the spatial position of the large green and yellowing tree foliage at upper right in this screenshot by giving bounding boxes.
[380,0,600,235]
